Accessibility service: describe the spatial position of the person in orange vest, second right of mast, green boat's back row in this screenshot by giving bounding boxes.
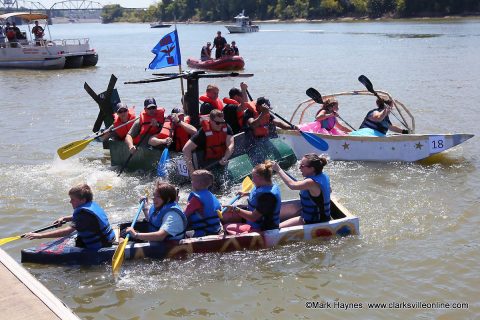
[223,82,252,134]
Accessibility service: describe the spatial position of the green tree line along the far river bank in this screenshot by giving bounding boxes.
[102,0,480,23]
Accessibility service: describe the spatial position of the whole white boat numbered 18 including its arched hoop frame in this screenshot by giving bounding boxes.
[278,90,474,162]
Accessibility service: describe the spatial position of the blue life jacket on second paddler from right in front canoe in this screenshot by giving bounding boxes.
[247,184,282,231]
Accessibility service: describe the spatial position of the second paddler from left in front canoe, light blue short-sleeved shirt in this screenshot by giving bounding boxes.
[125,182,187,241]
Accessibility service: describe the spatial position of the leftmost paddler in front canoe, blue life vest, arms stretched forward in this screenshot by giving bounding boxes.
[25,184,115,250]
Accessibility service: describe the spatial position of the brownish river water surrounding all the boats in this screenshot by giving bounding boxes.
[0,19,480,319]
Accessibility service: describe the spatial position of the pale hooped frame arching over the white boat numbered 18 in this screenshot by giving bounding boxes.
[290,90,415,133]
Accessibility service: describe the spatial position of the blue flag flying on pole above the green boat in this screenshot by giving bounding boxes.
[148,30,182,69]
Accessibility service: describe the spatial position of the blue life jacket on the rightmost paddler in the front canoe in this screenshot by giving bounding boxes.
[300,173,330,224]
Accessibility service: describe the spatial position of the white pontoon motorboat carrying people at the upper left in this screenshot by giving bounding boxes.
[0,12,98,69]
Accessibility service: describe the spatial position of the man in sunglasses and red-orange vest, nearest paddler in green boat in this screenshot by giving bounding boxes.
[183,109,234,175]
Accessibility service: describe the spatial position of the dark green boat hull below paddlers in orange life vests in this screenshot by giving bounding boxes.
[109,133,297,184]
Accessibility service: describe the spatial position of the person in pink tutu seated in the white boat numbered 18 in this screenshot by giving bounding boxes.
[299,99,351,136]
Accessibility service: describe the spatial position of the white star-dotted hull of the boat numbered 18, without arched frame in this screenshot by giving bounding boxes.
[279,130,473,162]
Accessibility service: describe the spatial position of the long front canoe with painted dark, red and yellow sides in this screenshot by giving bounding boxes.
[21,198,360,265]
